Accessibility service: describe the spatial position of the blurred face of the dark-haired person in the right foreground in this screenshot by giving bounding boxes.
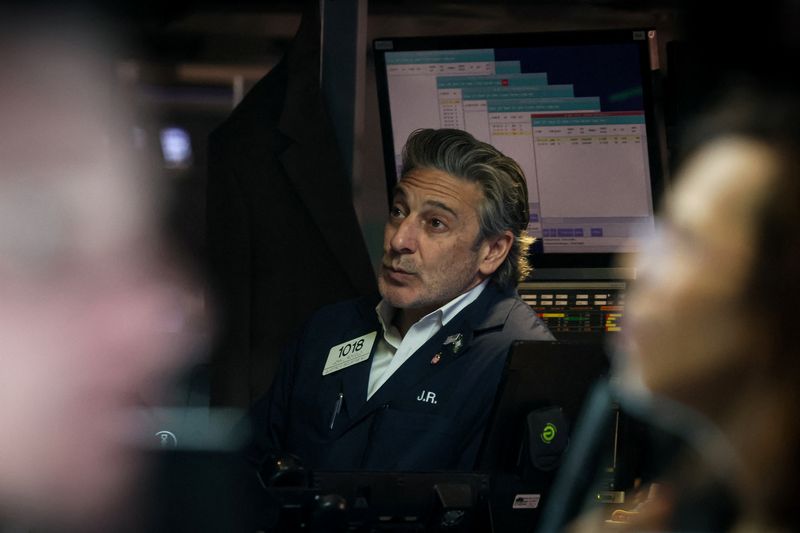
[623,138,775,409]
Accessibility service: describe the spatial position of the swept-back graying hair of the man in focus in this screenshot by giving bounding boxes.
[402,129,534,288]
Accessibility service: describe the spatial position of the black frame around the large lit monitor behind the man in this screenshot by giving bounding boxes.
[372,28,666,280]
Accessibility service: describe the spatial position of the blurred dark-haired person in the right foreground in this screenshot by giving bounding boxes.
[604,85,800,531]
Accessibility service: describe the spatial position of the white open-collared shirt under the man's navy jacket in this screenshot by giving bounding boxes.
[367,280,489,400]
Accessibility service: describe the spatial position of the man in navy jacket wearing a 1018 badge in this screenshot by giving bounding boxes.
[248,129,553,470]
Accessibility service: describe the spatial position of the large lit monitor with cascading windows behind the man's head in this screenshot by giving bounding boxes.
[373,29,660,268]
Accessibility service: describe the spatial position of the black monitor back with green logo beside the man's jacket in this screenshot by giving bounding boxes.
[478,339,612,533]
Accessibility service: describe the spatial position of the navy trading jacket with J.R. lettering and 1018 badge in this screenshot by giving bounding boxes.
[247,283,553,471]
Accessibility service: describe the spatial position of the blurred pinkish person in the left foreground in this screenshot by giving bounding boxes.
[0,14,200,531]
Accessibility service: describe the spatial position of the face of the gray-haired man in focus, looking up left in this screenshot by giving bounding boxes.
[378,168,484,314]
